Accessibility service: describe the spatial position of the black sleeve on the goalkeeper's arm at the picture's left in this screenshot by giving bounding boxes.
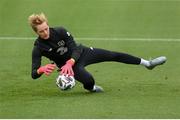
[31,46,42,79]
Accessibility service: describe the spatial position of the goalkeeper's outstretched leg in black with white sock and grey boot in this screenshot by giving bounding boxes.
[85,48,167,70]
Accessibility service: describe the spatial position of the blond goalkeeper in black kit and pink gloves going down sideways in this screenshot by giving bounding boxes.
[29,13,166,92]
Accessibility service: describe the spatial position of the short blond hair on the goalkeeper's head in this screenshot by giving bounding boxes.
[28,13,48,32]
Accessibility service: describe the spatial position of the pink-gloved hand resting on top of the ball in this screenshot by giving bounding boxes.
[60,59,74,76]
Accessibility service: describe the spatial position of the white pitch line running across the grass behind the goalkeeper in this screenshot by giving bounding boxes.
[0,37,180,42]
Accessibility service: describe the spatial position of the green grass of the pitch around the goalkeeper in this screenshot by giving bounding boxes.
[0,0,180,119]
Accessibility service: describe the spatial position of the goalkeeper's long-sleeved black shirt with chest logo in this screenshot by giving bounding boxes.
[31,27,83,79]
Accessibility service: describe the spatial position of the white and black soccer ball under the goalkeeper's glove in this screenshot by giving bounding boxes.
[56,75,76,90]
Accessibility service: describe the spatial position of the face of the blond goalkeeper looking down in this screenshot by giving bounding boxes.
[36,22,50,40]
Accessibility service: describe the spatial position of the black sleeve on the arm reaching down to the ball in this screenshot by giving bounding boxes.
[60,28,83,61]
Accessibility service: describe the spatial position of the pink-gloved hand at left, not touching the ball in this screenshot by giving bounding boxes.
[37,64,56,76]
